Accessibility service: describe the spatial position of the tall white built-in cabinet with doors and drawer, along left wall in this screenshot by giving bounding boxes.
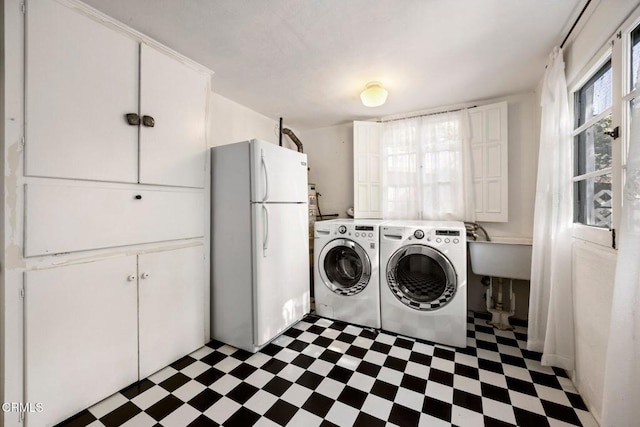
[18,0,210,427]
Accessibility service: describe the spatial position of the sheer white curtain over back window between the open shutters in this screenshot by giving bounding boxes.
[382,111,475,221]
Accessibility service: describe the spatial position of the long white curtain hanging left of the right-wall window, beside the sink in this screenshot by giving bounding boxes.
[527,47,575,370]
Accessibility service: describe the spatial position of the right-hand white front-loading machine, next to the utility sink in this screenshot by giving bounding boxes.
[380,221,467,347]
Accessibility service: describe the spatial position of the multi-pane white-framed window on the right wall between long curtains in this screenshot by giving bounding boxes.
[571,16,640,247]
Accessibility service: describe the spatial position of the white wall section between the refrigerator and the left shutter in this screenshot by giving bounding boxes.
[298,123,353,218]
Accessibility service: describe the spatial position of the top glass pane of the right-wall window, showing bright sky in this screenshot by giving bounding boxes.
[575,61,612,127]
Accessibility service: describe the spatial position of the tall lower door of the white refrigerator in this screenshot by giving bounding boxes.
[252,203,310,347]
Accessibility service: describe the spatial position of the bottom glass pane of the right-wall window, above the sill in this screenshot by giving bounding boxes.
[573,174,612,228]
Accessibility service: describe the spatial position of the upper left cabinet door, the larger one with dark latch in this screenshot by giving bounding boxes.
[25,0,139,182]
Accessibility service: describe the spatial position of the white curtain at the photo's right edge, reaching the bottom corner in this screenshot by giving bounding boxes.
[602,98,640,427]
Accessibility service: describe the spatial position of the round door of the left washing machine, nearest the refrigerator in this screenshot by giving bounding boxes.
[316,239,371,296]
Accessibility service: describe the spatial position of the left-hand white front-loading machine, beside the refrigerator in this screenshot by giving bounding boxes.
[313,219,382,329]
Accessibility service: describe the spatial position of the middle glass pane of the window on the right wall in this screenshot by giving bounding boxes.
[573,115,612,176]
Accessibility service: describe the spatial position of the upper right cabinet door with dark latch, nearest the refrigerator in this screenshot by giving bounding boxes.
[140,44,209,188]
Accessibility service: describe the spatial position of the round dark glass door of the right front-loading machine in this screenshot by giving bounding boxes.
[387,245,457,311]
